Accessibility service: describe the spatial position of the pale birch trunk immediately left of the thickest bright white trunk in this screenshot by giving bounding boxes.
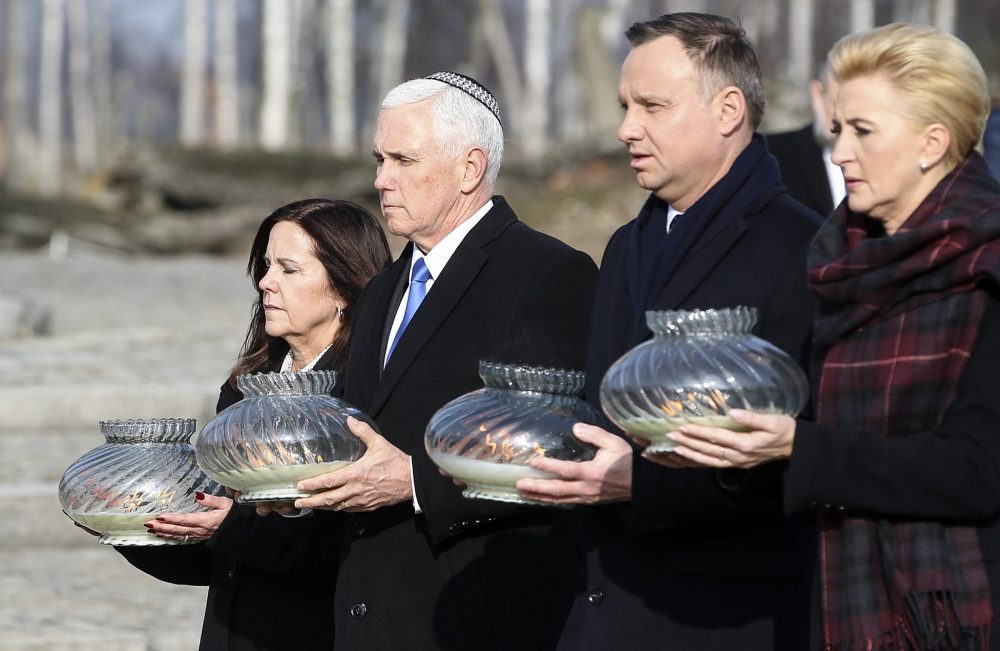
[215,0,240,149]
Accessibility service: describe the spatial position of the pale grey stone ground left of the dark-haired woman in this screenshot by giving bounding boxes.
[0,251,253,651]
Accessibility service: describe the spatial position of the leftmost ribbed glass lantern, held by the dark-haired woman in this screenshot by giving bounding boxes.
[59,418,223,545]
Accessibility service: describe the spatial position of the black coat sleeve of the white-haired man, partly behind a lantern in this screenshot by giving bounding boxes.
[408,251,597,543]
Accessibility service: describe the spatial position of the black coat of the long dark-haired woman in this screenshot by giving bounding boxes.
[115,353,339,651]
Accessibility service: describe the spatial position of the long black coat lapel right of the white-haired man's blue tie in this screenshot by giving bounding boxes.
[370,197,517,416]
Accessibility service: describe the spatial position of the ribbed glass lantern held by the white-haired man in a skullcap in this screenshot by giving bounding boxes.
[195,371,377,503]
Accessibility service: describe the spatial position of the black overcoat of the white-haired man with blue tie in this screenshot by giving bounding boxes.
[330,197,597,651]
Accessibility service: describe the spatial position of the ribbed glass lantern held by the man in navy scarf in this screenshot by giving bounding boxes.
[424,361,603,503]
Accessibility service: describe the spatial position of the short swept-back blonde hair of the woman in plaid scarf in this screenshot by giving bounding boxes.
[827,23,990,166]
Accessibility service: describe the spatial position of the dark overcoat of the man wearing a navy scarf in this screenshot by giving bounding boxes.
[559,158,819,651]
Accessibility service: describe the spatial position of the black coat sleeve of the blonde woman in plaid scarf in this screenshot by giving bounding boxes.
[784,297,1000,520]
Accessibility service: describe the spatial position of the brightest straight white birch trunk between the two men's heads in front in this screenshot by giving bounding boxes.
[519,0,552,160]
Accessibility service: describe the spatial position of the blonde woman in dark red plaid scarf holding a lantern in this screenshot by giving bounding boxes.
[671,24,1000,651]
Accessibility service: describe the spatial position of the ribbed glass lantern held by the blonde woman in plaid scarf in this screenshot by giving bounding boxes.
[600,306,809,452]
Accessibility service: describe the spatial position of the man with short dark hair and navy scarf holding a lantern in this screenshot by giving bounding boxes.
[518,13,820,651]
